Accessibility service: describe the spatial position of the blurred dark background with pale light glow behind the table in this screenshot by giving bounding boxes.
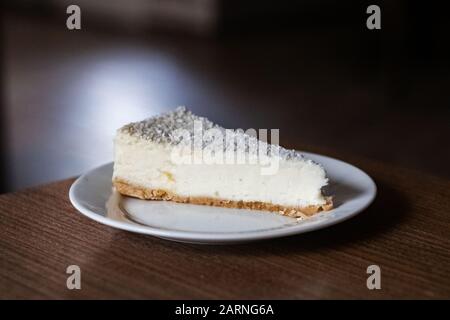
[0,0,450,192]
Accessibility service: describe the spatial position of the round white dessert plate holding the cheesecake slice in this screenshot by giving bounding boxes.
[69,152,376,244]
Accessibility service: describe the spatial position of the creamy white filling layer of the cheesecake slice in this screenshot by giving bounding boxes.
[113,132,328,207]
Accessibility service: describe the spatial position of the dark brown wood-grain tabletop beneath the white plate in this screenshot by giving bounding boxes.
[0,152,450,299]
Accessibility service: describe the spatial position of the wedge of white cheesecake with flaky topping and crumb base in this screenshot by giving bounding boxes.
[113,107,333,217]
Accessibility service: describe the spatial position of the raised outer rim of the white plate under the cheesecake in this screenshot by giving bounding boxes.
[69,151,378,244]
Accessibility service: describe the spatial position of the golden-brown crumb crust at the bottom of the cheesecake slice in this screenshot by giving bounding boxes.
[113,179,333,218]
